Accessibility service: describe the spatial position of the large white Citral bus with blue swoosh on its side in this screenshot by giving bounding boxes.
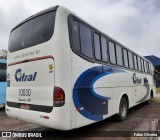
[6,6,155,130]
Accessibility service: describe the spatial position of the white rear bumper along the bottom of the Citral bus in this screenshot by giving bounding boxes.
[6,103,71,130]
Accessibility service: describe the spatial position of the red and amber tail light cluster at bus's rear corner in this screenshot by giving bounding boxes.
[53,86,65,107]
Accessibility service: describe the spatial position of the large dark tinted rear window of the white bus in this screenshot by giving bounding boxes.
[9,11,55,52]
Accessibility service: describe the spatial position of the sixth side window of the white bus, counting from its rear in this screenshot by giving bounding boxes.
[116,44,123,66]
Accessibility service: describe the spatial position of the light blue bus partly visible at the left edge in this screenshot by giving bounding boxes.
[0,59,7,107]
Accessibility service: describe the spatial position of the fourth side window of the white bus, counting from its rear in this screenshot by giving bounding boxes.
[101,36,108,62]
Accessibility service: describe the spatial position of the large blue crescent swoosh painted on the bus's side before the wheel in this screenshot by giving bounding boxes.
[73,66,125,121]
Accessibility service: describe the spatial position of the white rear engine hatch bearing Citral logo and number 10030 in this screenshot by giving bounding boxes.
[7,58,54,111]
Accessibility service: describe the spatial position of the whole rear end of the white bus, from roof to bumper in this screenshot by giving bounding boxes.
[6,6,69,130]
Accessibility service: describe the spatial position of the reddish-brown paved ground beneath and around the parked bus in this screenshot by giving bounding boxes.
[0,100,160,140]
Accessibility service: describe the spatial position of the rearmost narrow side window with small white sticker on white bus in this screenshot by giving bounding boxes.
[72,20,80,52]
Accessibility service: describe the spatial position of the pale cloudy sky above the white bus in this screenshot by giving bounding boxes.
[0,0,160,57]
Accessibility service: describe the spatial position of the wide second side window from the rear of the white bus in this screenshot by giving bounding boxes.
[80,23,93,58]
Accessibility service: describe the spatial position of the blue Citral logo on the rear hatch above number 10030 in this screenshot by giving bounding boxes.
[15,69,37,82]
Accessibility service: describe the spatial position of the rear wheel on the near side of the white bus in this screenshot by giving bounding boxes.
[116,97,128,122]
